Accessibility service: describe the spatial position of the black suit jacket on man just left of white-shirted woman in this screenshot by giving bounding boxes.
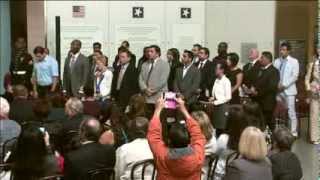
[195,60,215,99]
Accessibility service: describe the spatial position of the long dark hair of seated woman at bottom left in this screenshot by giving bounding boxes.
[12,123,47,180]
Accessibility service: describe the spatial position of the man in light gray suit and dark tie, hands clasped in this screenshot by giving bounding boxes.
[139,45,170,116]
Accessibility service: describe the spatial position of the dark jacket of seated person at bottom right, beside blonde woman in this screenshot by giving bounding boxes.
[270,151,302,180]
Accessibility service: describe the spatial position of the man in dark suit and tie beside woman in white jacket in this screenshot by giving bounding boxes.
[111,49,139,110]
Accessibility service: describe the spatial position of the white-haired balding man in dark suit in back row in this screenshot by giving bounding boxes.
[243,48,261,88]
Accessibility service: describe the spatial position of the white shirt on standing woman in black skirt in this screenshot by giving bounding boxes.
[212,75,232,106]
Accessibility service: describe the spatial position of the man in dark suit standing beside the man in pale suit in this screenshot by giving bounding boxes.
[250,51,280,131]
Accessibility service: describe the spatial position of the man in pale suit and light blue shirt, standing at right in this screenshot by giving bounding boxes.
[274,42,299,137]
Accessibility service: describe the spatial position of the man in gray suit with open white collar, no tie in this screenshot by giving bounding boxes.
[174,50,201,106]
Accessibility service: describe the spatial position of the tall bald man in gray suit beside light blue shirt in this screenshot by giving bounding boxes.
[63,40,89,96]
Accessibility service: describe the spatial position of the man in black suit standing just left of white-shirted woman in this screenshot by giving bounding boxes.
[194,47,215,101]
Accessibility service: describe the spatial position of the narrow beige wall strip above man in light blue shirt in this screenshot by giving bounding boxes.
[27,1,45,53]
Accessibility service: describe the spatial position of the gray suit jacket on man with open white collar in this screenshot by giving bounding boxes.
[174,66,201,105]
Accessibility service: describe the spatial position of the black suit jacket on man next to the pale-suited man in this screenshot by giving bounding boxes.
[252,65,280,111]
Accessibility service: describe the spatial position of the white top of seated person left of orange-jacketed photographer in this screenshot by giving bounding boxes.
[115,138,153,180]
